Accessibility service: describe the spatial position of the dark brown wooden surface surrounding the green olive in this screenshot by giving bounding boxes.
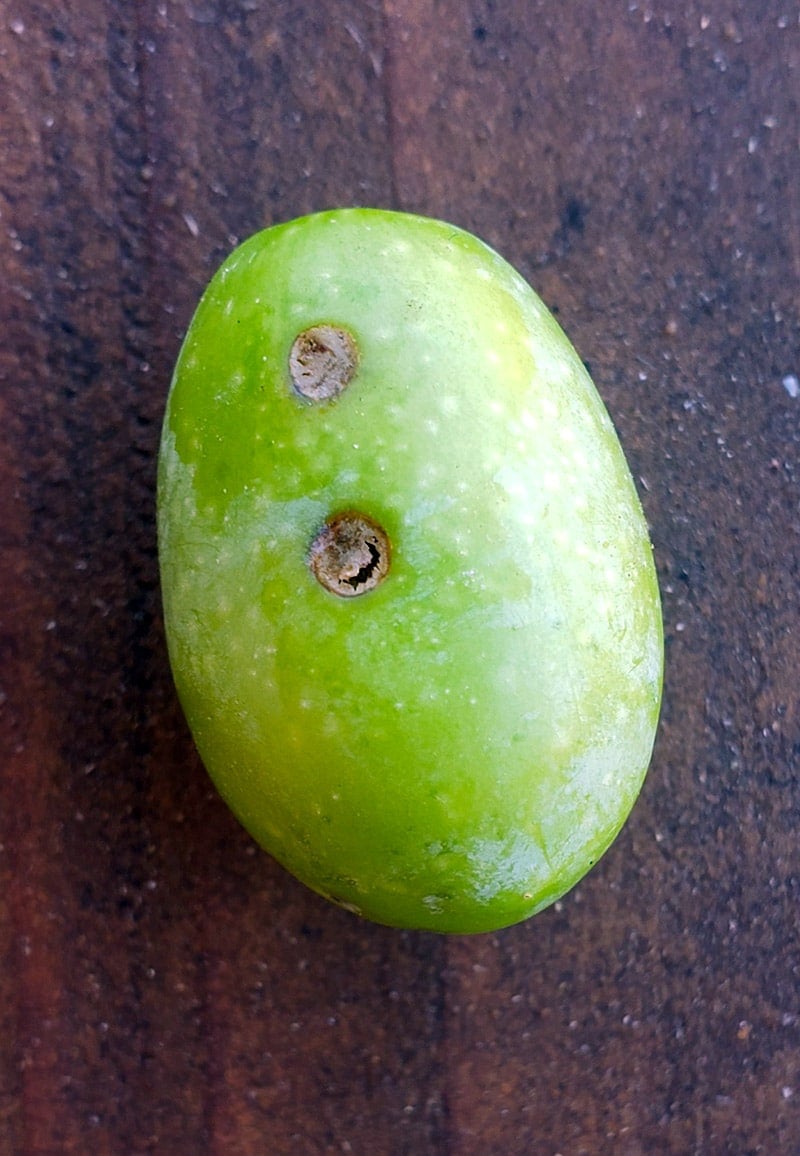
[0,0,800,1156]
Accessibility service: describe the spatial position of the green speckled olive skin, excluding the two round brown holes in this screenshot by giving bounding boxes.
[158,209,664,932]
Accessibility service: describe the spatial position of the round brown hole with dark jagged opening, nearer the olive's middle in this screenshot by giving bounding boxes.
[309,510,391,598]
